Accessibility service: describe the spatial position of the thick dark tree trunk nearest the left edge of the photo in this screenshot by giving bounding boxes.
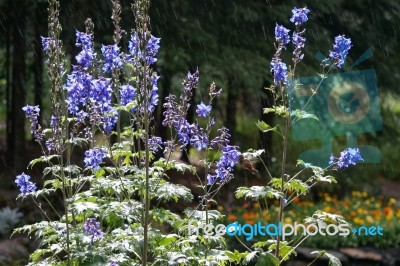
[7,0,27,173]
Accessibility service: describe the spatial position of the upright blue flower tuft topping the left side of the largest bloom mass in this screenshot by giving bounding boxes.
[75,31,96,68]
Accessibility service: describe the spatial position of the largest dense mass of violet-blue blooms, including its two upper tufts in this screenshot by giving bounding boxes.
[65,31,117,133]
